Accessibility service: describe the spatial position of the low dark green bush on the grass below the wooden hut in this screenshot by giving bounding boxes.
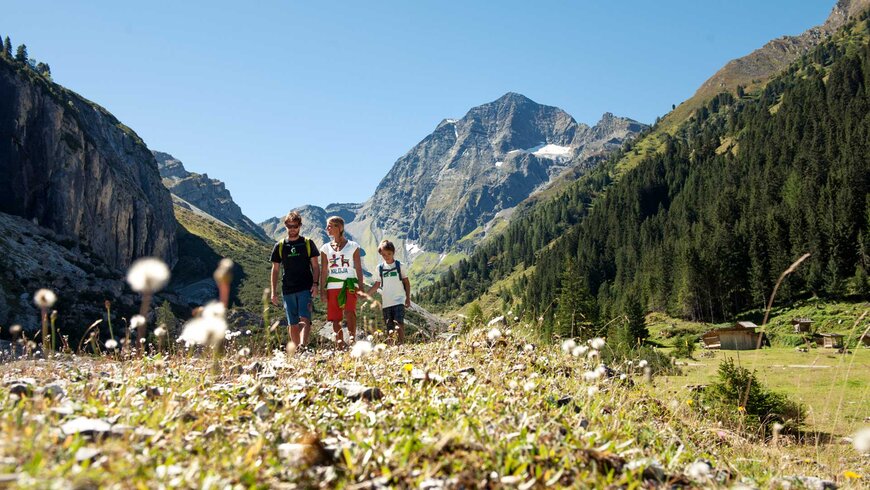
[701,358,804,433]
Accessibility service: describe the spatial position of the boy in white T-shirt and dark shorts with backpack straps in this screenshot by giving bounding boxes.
[369,240,411,344]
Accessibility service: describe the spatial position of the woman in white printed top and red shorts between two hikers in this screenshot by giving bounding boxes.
[320,216,363,346]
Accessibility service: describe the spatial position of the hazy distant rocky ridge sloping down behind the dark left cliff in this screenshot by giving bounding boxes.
[153,151,269,240]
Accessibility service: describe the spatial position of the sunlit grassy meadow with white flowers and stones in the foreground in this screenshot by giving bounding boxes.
[0,314,870,488]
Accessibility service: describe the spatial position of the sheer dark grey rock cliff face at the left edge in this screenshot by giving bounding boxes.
[0,59,177,268]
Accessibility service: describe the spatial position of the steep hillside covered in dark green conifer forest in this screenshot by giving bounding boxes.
[421,13,870,334]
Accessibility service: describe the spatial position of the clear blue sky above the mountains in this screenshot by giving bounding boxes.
[0,0,834,221]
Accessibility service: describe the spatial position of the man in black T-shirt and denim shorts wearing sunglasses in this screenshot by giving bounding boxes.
[271,211,320,347]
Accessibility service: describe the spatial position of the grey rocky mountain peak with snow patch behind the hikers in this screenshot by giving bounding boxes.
[260,93,646,272]
